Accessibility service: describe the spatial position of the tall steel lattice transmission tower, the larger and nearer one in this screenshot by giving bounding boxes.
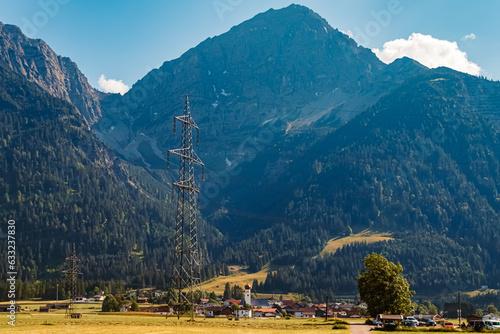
[167,95,205,319]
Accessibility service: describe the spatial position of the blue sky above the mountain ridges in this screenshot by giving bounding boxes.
[0,0,500,92]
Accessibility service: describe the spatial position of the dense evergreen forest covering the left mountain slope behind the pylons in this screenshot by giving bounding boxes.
[0,63,226,288]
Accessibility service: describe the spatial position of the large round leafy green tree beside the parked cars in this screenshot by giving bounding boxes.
[358,253,415,316]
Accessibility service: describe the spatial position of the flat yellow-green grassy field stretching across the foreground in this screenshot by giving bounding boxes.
[0,312,350,334]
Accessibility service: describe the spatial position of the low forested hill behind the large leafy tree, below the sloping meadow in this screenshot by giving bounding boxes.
[257,231,485,300]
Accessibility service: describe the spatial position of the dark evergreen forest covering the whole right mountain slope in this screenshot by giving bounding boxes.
[213,69,500,296]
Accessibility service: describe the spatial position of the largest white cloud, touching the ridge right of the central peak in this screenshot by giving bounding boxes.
[372,33,482,75]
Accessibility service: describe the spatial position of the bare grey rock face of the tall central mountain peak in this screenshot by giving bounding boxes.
[94,5,386,168]
